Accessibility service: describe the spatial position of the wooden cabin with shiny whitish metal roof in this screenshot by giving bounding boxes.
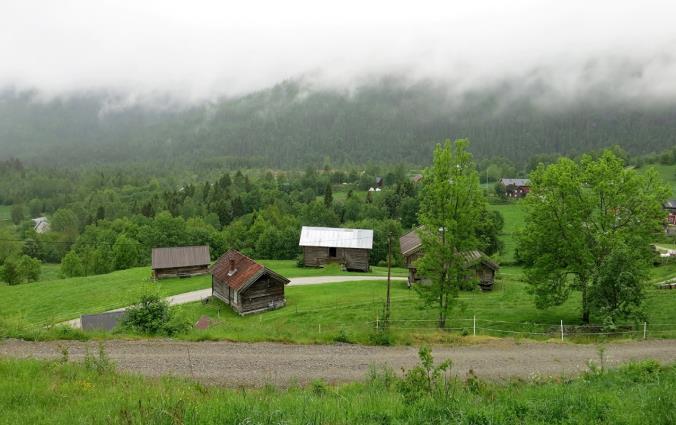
[298,226,373,272]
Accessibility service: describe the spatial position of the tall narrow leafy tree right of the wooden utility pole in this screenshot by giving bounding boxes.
[416,140,485,327]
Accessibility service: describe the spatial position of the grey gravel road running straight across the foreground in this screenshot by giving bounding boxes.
[0,340,676,386]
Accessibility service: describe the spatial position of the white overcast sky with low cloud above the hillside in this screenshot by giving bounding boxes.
[0,0,676,101]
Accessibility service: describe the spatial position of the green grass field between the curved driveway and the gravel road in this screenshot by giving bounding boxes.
[176,266,676,344]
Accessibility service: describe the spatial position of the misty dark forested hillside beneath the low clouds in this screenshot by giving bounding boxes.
[0,81,676,168]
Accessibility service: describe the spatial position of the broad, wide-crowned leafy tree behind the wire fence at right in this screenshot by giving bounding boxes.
[519,150,668,326]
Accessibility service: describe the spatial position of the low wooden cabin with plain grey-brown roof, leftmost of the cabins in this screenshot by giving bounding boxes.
[152,245,211,279]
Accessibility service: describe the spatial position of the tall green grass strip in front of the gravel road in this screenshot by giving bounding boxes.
[0,353,676,425]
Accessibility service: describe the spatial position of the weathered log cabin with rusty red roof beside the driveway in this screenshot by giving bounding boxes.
[211,250,289,315]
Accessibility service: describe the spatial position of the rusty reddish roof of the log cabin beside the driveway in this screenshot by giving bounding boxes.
[211,249,289,290]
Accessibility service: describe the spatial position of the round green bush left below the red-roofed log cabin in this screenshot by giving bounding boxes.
[122,294,188,336]
